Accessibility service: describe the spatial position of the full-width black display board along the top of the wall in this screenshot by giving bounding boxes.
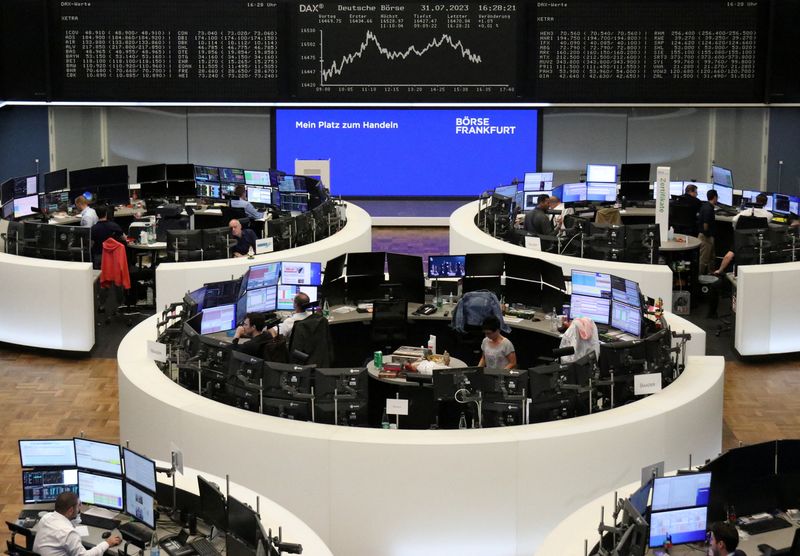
[0,0,800,104]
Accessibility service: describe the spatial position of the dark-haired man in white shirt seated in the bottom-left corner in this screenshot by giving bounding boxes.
[33,491,122,556]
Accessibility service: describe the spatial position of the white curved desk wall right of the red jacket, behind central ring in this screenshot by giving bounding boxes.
[156,203,372,309]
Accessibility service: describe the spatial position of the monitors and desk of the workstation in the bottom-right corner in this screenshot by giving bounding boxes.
[591,440,800,556]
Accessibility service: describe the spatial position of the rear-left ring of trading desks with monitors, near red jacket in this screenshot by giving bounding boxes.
[0,164,343,261]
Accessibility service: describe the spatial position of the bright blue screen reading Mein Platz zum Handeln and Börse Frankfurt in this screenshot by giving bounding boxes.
[275,108,539,197]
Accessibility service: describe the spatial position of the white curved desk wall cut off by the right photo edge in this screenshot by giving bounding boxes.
[734,262,800,355]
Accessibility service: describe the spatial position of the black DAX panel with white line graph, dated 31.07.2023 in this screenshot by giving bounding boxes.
[292,1,518,100]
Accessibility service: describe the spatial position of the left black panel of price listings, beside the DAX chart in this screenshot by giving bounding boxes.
[50,0,279,100]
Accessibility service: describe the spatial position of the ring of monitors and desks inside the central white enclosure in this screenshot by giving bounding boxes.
[153,252,683,428]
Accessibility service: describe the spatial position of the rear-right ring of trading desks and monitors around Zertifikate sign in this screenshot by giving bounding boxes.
[477,164,800,264]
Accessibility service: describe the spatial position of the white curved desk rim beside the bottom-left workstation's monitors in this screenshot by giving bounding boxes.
[148,458,332,556]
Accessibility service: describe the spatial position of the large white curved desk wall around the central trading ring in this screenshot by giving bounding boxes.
[118,317,724,556]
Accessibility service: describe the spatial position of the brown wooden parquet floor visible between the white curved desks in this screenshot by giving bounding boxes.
[0,228,800,540]
